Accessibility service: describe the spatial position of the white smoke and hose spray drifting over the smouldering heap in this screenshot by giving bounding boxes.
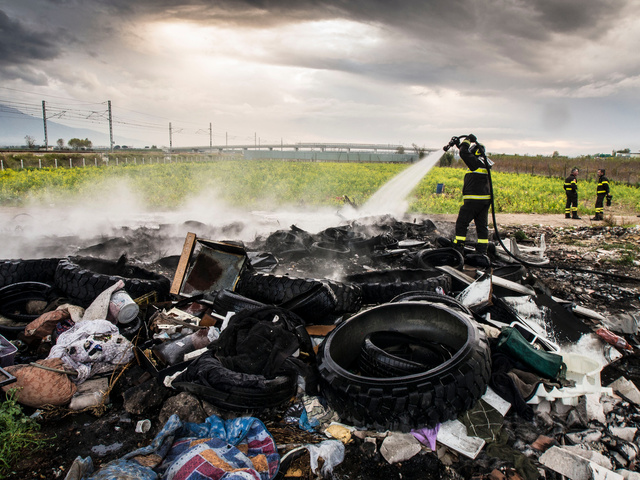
[0,152,440,262]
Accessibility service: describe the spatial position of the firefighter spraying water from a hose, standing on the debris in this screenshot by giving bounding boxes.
[452,134,491,255]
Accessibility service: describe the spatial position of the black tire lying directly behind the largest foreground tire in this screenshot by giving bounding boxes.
[346,269,451,305]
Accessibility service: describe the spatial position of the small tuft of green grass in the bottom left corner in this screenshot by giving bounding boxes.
[0,390,47,478]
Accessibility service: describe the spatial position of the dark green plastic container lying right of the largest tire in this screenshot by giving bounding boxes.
[496,327,567,379]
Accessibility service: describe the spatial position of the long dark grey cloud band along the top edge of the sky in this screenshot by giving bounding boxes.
[74,0,628,41]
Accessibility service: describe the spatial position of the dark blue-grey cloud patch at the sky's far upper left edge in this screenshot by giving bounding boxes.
[0,10,60,69]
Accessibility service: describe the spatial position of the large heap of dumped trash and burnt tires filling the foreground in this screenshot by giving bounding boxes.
[0,217,640,480]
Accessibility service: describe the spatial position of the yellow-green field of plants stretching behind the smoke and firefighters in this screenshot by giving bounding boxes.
[0,159,640,215]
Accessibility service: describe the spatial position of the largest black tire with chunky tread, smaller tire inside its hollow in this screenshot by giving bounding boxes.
[317,302,491,432]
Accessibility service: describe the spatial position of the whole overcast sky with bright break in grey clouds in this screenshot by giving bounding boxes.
[0,0,640,155]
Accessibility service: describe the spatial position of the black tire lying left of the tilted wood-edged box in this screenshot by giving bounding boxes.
[54,258,171,307]
